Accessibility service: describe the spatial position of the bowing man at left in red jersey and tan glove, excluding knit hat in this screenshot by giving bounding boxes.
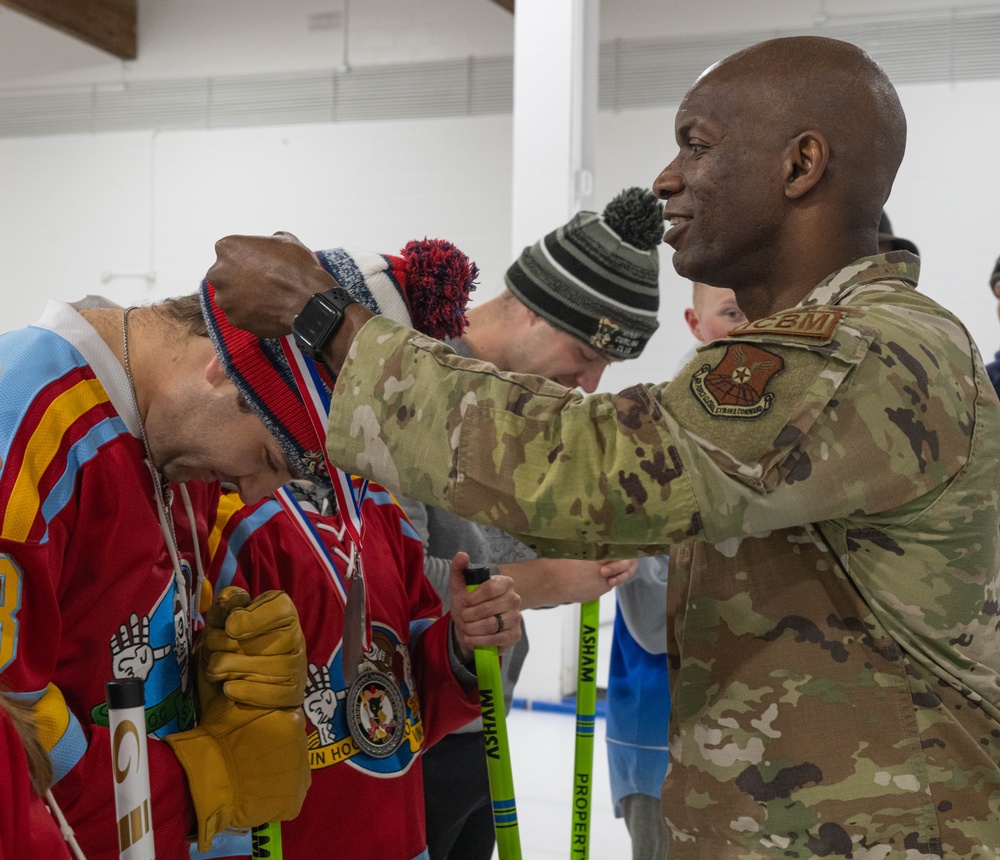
[0,237,484,860]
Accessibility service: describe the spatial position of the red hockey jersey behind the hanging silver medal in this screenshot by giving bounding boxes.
[208,484,479,860]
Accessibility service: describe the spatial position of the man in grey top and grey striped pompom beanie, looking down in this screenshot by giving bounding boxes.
[399,188,663,860]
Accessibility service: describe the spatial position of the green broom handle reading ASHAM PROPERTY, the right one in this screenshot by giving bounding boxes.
[569,600,601,860]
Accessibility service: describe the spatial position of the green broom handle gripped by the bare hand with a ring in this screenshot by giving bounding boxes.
[465,567,521,860]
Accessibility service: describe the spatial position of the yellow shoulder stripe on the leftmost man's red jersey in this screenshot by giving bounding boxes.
[2,379,108,541]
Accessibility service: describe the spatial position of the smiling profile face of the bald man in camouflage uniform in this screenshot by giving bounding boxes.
[653,71,783,288]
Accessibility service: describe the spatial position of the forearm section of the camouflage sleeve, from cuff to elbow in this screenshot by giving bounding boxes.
[327,317,697,557]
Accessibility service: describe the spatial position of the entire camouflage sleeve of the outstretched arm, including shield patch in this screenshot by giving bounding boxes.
[328,310,974,557]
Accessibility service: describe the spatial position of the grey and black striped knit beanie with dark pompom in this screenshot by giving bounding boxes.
[505,188,664,359]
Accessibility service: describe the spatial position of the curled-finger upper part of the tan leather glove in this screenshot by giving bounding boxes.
[196,586,308,708]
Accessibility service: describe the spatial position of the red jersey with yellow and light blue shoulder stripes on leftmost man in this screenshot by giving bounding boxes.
[0,303,219,860]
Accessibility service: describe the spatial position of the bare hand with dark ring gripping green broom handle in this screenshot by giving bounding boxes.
[451,552,521,663]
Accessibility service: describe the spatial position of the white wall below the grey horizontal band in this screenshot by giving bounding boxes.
[13,77,1000,382]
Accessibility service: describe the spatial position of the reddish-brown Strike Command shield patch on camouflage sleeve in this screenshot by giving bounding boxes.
[691,343,785,418]
